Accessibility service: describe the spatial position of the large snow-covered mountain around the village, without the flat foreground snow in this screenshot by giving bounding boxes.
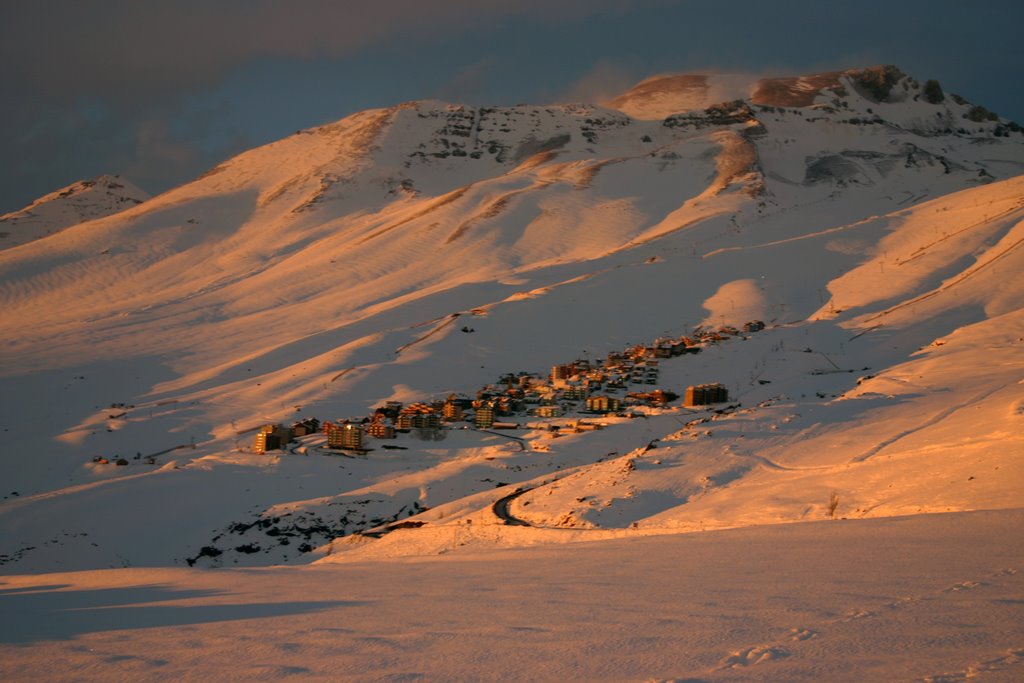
[0,68,1024,571]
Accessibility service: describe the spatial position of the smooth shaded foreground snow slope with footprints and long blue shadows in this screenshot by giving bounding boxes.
[0,510,1024,683]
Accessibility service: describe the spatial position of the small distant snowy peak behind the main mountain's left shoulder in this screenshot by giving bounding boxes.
[0,175,150,249]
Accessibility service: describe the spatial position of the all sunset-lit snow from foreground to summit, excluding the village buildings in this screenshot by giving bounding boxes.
[0,68,1024,682]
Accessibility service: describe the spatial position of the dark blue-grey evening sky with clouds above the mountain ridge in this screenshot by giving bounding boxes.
[0,0,1024,213]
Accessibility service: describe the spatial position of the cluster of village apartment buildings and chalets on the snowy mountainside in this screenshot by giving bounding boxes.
[247,321,764,453]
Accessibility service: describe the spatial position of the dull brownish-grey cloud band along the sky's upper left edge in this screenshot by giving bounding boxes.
[0,0,643,102]
